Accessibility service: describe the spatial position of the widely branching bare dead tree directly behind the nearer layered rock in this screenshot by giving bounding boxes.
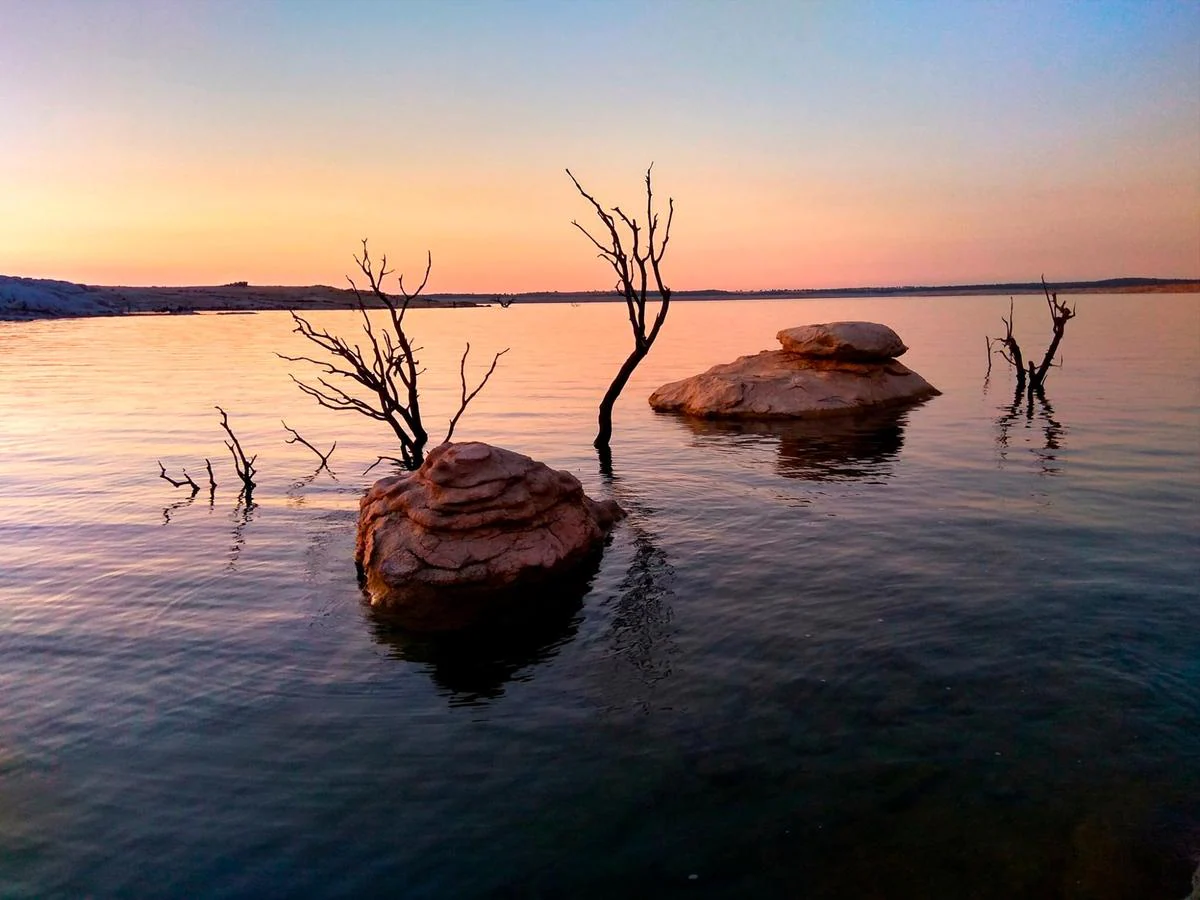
[276,239,508,469]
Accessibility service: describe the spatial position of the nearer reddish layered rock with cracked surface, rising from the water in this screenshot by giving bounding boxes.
[355,443,624,630]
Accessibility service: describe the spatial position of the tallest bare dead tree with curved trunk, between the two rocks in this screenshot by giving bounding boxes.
[566,163,674,455]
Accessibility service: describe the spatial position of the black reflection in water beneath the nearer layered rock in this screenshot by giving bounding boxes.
[370,564,600,703]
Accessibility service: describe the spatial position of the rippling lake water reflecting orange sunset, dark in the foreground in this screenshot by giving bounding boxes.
[0,296,1200,900]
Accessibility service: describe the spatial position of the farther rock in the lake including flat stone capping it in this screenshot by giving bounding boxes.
[650,322,941,419]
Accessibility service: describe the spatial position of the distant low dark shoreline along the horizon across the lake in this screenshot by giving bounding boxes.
[0,276,1200,320]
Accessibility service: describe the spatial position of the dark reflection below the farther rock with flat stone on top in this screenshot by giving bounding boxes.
[680,407,908,481]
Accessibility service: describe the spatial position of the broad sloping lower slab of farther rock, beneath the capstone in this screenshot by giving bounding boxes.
[650,355,941,419]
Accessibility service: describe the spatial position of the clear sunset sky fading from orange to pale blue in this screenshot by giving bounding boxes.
[0,0,1200,293]
